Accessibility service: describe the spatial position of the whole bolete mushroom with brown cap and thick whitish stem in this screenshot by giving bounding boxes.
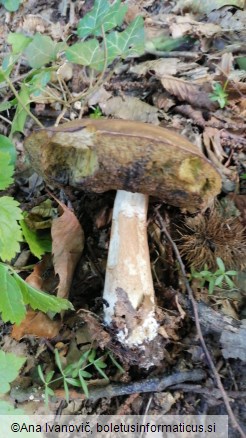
[25,119,221,364]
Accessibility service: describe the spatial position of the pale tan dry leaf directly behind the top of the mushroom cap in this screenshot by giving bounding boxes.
[99,96,159,125]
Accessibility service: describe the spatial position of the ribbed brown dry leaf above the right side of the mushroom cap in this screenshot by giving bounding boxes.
[160,75,217,110]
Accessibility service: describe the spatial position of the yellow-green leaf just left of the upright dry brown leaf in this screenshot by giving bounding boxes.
[20,220,52,259]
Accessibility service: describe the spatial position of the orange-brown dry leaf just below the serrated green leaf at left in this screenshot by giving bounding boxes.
[11,310,61,341]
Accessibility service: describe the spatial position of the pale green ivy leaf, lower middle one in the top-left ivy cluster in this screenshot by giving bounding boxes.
[65,39,99,66]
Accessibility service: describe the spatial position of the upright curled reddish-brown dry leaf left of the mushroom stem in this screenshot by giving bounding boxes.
[51,201,84,298]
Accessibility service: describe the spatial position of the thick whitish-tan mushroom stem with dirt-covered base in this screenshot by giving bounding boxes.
[103,190,158,347]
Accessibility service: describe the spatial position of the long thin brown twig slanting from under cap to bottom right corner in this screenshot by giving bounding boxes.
[155,208,246,438]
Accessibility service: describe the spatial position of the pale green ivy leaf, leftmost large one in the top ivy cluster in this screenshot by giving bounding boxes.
[24,33,56,68]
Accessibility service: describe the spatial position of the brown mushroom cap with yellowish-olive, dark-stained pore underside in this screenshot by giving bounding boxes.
[25,119,221,211]
